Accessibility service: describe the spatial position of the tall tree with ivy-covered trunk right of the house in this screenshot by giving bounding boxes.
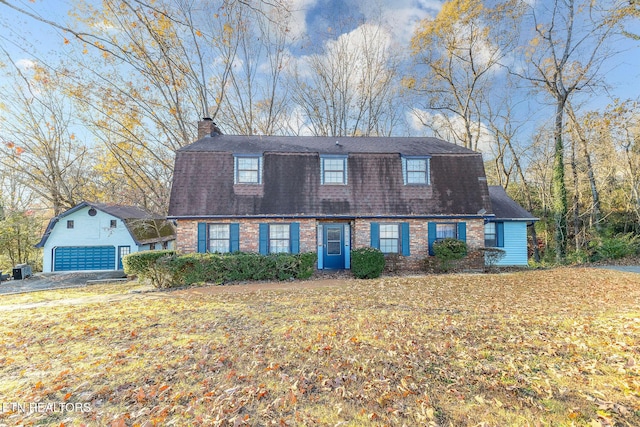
[523,0,628,261]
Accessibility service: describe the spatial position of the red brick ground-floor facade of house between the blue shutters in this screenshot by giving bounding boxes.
[176,218,484,270]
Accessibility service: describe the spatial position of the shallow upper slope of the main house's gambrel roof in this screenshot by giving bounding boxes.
[178,135,478,156]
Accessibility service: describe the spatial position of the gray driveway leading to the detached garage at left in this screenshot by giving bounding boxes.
[0,270,126,295]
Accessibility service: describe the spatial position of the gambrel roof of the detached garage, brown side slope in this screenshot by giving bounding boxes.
[35,202,176,248]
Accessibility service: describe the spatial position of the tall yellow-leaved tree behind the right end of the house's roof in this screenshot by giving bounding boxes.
[404,0,522,150]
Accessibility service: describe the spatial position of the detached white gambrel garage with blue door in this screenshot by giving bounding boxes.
[36,202,175,272]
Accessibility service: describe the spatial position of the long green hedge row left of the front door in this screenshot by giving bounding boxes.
[123,251,317,288]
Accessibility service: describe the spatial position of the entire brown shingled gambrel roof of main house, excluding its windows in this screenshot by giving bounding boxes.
[169,135,492,219]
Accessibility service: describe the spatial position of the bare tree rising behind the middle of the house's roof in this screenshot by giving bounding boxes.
[291,23,399,136]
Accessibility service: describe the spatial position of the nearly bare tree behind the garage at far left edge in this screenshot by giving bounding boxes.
[0,55,91,215]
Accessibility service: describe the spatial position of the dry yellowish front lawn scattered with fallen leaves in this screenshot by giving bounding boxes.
[0,268,640,426]
